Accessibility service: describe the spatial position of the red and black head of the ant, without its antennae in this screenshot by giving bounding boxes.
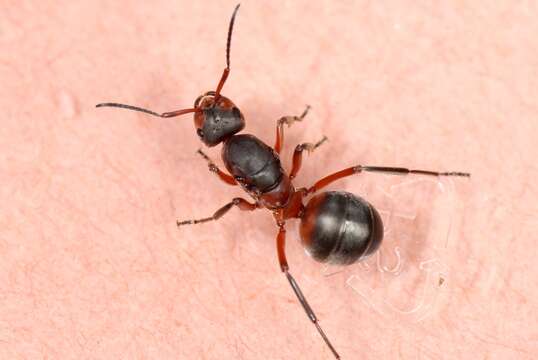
[194,91,245,146]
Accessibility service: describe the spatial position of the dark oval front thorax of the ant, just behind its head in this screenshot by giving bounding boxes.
[222,134,283,193]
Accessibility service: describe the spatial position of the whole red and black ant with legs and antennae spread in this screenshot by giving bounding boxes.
[97,5,470,359]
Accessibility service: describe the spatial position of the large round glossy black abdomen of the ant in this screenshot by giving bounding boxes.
[300,191,383,265]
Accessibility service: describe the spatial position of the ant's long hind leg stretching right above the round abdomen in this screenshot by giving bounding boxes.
[307,165,471,194]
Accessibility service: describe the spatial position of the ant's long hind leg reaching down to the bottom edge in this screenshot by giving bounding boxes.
[276,223,340,359]
